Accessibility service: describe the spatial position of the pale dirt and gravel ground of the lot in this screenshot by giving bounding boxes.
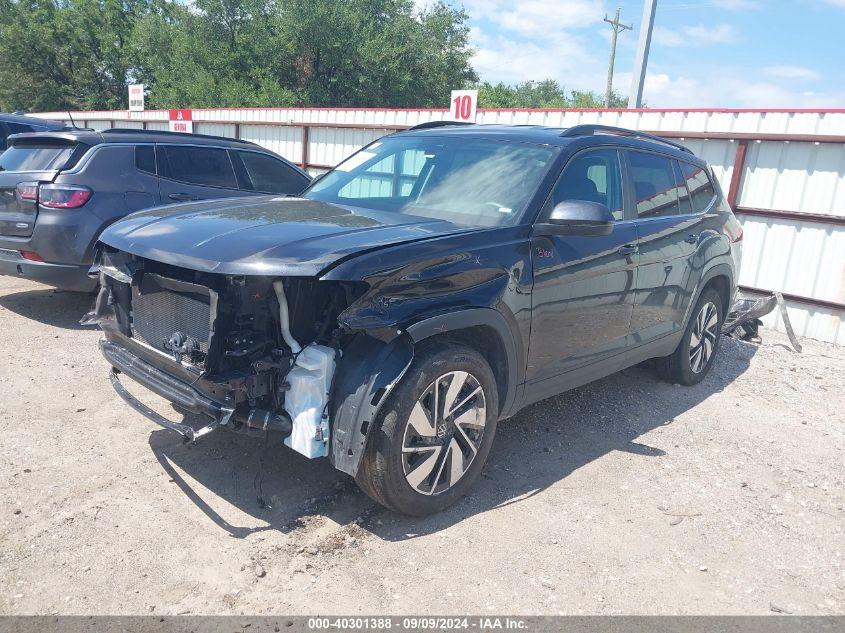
[0,277,845,614]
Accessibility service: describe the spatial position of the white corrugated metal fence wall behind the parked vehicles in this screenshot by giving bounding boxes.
[29,108,845,344]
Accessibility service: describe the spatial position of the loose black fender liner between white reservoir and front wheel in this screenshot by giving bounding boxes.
[329,333,414,477]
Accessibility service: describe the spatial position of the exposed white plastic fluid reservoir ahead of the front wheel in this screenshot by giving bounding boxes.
[285,345,335,458]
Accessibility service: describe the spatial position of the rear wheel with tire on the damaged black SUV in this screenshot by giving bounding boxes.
[657,288,724,386]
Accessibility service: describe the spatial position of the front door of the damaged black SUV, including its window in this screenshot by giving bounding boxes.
[526,148,639,381]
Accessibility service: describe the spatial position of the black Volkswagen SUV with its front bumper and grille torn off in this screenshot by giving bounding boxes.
[88,124,742,515]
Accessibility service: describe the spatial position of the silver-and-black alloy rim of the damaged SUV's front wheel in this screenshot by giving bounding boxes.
[402,371,487,495]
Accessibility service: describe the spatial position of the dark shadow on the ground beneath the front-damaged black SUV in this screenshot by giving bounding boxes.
[150,338,757,541]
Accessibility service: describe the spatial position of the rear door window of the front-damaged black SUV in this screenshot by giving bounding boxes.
[628,151,679,218]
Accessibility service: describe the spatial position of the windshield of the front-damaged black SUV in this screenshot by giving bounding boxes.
[303,136,556,227]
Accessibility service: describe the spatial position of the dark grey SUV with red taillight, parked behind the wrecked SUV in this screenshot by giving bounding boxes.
[0,129,311,291]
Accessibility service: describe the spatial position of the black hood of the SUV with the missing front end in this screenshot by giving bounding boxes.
[100,196,471,276]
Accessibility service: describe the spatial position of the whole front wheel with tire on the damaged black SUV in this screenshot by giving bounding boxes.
[356,341,499,516]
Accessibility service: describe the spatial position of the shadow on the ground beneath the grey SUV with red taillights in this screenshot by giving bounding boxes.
[0,288,94,330]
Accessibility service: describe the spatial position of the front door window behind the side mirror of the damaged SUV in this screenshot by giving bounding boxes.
[549,149,623,220]
